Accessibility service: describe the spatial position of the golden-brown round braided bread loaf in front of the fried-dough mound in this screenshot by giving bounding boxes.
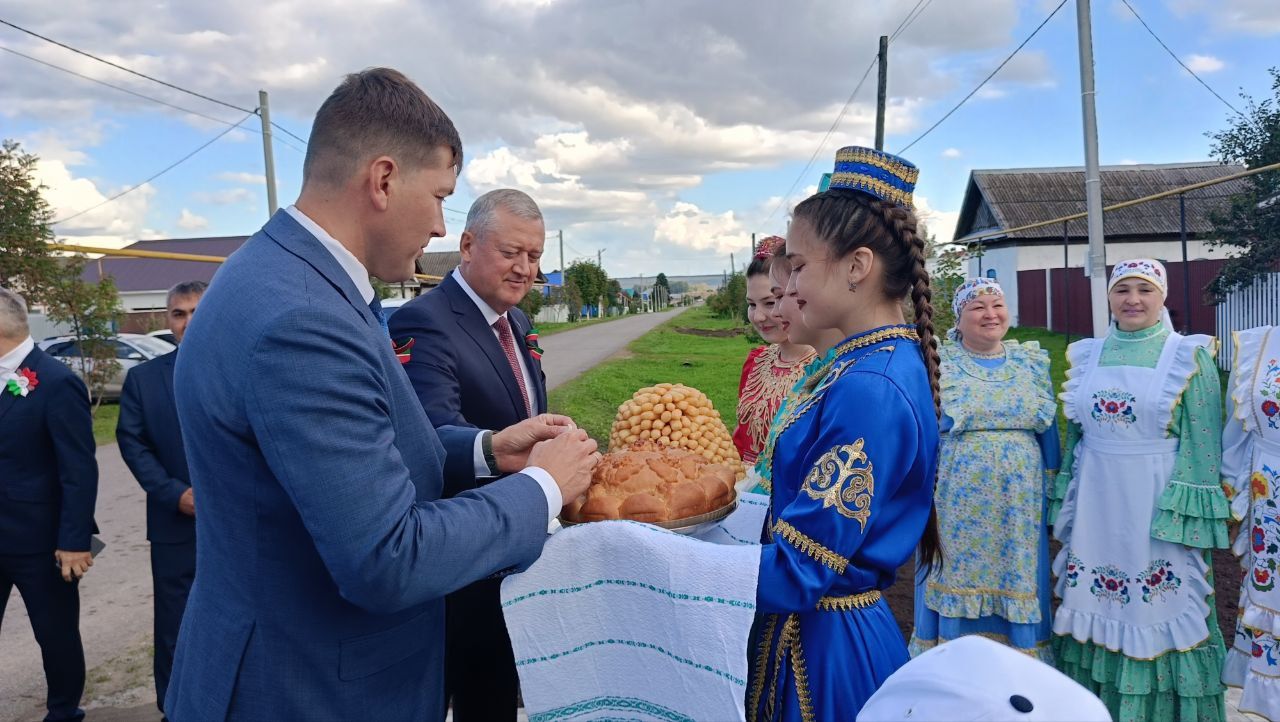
[566,442,735,522]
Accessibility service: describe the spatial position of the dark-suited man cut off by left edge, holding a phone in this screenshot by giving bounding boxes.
[0,288,97,721]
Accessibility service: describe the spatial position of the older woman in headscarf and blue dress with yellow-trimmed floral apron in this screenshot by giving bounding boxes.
[910,278,1061,662]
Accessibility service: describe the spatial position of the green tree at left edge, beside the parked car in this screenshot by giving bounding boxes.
[0,141,122,412]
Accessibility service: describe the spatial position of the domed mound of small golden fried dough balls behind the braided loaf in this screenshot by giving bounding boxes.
[609,384,746,479]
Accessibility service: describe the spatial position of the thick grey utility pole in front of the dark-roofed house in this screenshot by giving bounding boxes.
[1075,0,1108,335]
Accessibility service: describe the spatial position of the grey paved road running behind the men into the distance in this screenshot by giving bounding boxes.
[0,311,677,722]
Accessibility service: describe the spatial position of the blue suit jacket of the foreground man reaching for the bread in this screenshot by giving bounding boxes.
[165,211,548,722]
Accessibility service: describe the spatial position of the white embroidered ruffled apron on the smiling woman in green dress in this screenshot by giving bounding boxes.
[1053,333,1212,659]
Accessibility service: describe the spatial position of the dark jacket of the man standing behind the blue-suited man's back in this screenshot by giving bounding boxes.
[115,351,196,544]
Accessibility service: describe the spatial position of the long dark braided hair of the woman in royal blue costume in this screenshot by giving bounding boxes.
[794,188,942,570]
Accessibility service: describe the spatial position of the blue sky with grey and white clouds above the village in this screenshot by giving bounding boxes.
[0,0,1280,277]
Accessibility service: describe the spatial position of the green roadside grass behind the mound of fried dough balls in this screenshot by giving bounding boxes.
[549,306,754,444]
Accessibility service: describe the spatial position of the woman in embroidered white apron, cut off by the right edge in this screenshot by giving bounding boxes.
[1222,326,1280,722]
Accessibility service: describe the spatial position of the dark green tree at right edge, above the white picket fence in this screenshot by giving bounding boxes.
[1207,68,1280,298]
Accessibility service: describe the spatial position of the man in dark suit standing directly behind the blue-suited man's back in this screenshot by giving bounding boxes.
[115,280,206,712]
